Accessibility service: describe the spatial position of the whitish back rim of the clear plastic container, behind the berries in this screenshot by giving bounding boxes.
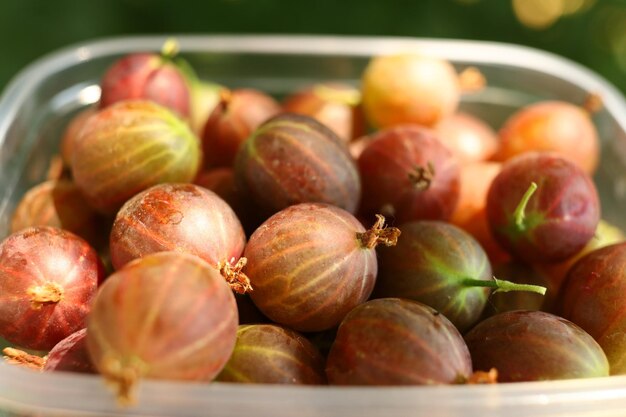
[0,34,626,146]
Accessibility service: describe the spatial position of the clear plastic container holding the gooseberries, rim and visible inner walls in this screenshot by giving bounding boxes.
[0,36,626,417]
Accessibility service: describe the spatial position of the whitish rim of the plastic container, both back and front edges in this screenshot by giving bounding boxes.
[0,35,626,417]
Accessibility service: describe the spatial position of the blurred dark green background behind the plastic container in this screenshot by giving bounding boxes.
[0,0,626,92]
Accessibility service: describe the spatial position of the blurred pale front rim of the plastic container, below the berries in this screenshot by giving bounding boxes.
[0,364,626,417]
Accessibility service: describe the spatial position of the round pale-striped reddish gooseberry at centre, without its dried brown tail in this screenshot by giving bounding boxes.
[244,203,378,332]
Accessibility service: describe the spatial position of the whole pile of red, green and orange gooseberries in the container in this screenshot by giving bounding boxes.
[0,38,626,402]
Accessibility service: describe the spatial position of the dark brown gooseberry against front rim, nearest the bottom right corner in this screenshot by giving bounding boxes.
[465,310,609,382]
